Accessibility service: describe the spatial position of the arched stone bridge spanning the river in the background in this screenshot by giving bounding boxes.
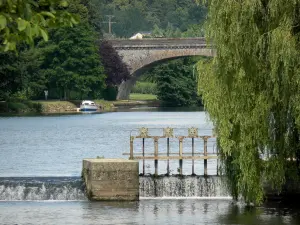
[110,38,215,99]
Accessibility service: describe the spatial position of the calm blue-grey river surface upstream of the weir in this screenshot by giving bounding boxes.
[0,112,215,177]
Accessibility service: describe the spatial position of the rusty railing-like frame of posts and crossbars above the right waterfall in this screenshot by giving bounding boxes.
[123,127,218,176]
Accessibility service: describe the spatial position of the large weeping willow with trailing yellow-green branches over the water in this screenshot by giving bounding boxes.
[197,0,300,204]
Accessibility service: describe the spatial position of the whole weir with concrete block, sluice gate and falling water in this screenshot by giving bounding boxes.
[0,128,221,201]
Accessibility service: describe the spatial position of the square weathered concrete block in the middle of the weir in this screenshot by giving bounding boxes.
[82,159,139,201]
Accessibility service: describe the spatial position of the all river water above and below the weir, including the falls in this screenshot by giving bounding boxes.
[0,109,300,224]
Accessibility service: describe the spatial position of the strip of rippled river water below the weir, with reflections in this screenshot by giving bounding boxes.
[0,200,300,225]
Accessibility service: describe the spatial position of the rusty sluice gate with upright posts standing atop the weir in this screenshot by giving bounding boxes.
[123,127,219,176]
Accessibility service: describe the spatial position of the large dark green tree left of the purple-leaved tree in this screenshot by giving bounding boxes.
[39,0,106,99]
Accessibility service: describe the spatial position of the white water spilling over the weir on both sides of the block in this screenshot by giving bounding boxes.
[0,176,229,201]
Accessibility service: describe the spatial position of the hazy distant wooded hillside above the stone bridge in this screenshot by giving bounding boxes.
[92,0,206,38]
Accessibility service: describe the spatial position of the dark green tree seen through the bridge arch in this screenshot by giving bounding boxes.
[150,58,200,106]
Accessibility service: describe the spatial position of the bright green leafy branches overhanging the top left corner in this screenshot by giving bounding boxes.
[0,0,77,51]
